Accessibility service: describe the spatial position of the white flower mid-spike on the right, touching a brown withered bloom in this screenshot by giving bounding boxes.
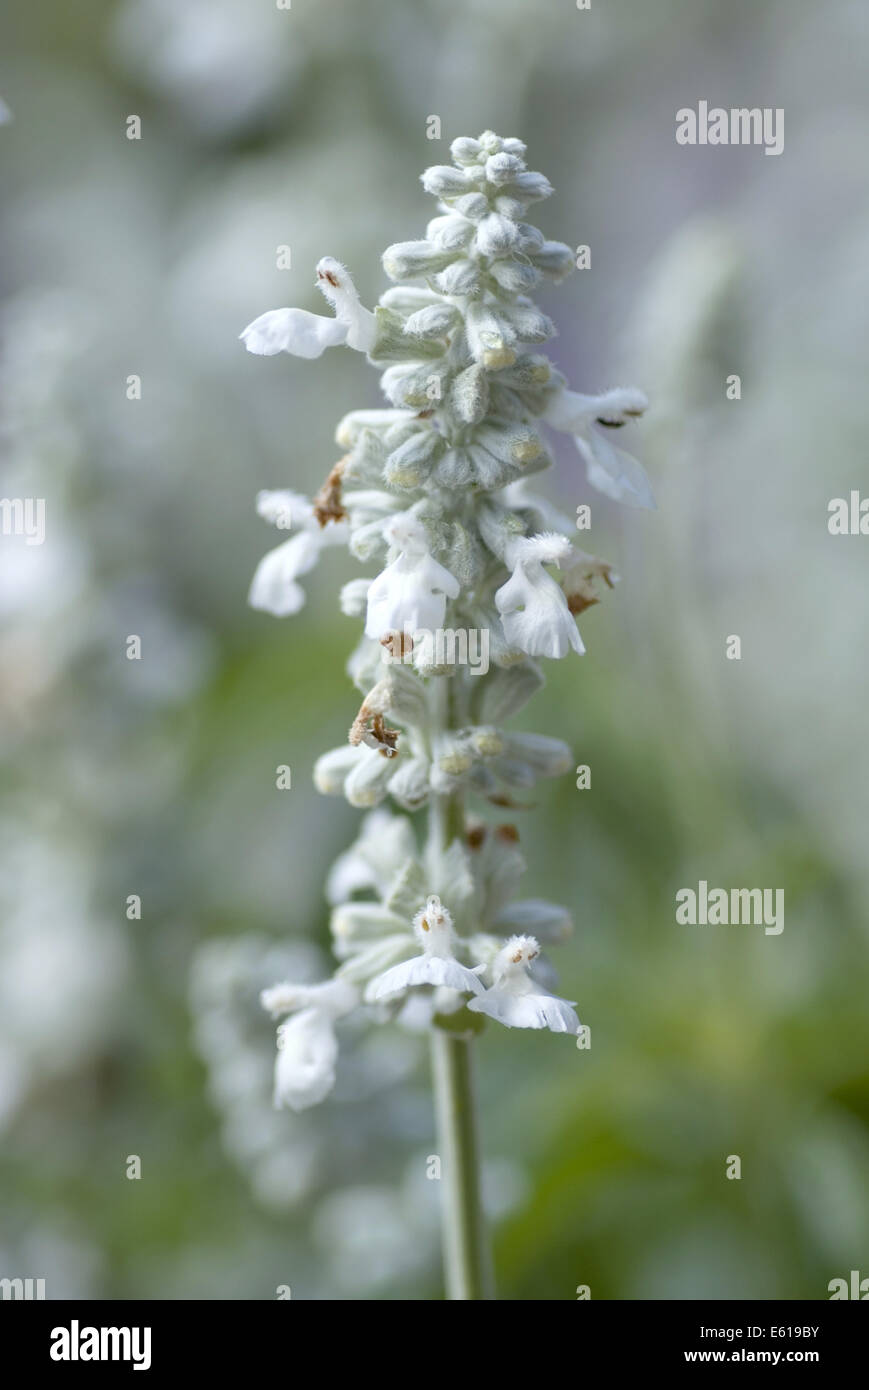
[495,532,585,659]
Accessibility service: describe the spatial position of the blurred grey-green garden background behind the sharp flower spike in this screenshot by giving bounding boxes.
[0,0,869,1300]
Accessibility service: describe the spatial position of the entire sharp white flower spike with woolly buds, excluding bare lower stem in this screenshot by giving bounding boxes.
[241,132,655,1109]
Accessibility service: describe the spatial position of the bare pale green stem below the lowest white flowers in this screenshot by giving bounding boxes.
[431,1027,494,1300]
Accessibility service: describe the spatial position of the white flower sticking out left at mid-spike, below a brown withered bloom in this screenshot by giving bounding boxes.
[247,492,348,617]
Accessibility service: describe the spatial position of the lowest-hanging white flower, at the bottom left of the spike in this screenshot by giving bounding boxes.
[260,980,359,1111]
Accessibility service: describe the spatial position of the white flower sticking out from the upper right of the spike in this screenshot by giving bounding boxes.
[542,386,655,510]
